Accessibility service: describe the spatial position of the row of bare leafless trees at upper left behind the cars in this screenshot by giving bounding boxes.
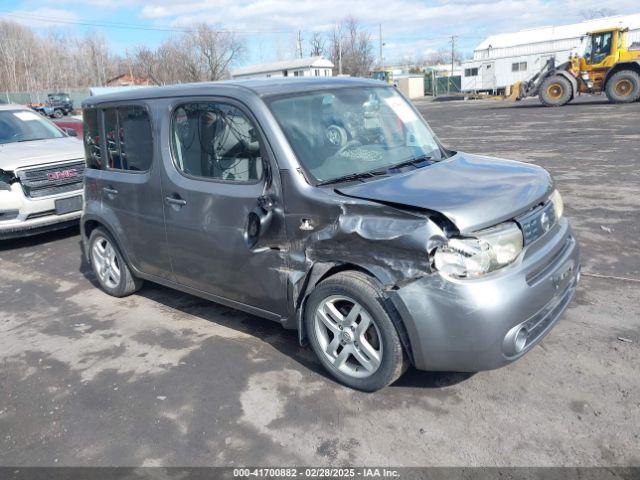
[0,21,244,94]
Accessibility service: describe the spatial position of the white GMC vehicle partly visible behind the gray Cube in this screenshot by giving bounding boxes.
[0,105,85,239]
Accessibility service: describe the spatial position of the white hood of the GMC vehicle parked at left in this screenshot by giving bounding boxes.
[0,137,84,170]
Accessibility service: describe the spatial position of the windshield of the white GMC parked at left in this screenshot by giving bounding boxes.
[0,110,65,144]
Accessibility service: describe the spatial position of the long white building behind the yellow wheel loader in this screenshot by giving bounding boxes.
[461,14,640,92]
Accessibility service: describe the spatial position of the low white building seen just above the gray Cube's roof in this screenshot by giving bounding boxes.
[231,57,333,78]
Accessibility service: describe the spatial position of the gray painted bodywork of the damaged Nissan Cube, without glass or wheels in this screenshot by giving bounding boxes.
[82,78,579,371]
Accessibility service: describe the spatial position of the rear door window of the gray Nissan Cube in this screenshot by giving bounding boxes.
[104,105,153,172]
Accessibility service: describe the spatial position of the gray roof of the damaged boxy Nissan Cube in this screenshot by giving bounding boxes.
[82,77,388,107]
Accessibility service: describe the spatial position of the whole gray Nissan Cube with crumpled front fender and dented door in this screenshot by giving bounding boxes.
[81,78,580,391]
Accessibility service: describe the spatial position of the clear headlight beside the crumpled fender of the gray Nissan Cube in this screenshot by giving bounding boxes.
[433,222,523,278]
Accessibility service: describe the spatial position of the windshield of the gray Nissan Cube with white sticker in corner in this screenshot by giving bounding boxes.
[268,87,444,183]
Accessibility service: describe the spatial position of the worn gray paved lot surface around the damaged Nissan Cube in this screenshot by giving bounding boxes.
[0,98,640,466]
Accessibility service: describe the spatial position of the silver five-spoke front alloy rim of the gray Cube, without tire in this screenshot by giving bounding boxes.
[314,295,382,378]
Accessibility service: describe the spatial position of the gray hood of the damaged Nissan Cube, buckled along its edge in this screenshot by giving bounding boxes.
[336,153,552,232]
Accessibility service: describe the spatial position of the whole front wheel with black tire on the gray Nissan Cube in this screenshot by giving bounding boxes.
[304,271,408,392]
